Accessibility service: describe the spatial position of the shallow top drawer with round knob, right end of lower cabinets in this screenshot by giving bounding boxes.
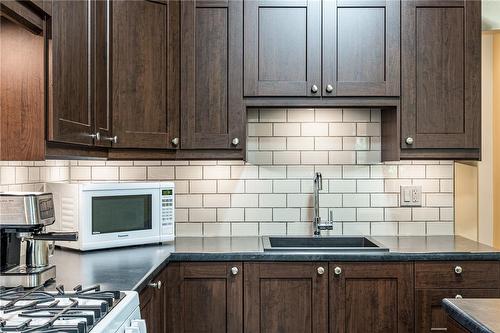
[415,261,500,288]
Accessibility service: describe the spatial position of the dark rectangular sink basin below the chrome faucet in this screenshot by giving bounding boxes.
[262,236,389,252]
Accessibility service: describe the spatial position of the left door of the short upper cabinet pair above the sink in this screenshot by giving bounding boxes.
[244,0,321,97]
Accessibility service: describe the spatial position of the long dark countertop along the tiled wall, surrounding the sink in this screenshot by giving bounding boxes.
[51,236,500,291]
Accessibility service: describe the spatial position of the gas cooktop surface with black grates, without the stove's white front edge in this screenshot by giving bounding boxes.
[0,285,133,333]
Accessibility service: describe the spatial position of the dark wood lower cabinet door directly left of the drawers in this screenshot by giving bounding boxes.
[330,262,413,333]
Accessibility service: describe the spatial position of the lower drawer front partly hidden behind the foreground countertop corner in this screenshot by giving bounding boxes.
[415,289,500,333]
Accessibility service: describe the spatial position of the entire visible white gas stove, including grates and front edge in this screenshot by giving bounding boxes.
[0,286,146,333]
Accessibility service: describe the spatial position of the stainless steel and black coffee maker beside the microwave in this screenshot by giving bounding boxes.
[0,192,78,288]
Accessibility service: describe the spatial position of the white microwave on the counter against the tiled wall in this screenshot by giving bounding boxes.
[46,182,175,251]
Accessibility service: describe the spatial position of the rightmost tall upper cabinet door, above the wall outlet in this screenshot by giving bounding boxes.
[401,0,481,149]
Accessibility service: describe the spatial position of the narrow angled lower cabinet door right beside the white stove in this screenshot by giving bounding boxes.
[139,269,168,333]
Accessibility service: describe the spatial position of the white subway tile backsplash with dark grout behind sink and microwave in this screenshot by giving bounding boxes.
[0,108,454,236]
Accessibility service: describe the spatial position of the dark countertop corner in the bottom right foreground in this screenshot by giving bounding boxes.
[443,298,500,333]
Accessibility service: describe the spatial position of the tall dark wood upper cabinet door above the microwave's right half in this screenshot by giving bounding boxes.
[110,0,179,148]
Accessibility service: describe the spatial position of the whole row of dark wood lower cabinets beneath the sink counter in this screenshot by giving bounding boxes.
[140,261,500,333]
